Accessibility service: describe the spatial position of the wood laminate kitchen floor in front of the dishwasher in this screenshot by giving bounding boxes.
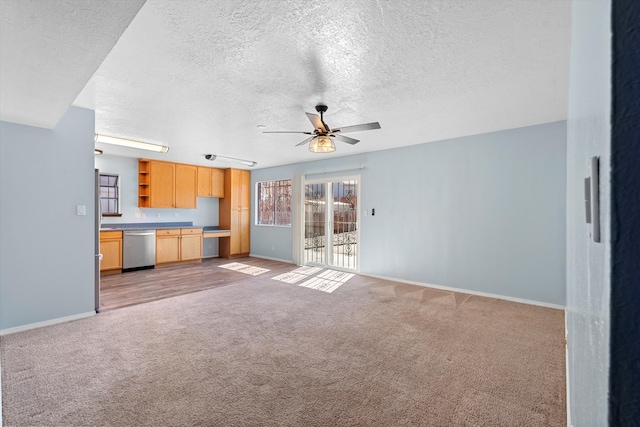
[100,257,297,311]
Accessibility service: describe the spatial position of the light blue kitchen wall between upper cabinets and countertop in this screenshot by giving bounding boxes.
[95,155,218,226]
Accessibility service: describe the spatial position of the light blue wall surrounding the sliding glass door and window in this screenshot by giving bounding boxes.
[251,122,566,305]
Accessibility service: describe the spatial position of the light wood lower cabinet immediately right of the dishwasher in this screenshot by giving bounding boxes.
[156,228,202,265]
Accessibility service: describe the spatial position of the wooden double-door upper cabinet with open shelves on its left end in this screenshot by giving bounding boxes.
[138,159,205,209]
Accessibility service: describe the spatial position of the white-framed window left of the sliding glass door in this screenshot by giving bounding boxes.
[256,179,291,227]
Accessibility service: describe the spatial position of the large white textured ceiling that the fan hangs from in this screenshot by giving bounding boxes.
[1,0,571,167]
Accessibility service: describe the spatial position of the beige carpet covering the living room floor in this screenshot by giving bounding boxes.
[0,265,566,426]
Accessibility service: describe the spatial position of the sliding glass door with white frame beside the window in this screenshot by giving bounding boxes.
[303,177,360,271]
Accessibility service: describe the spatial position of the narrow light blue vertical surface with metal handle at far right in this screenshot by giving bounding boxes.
[567,0,611,426]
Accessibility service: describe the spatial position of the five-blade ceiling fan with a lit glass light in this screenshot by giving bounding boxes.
[263,104,380,153]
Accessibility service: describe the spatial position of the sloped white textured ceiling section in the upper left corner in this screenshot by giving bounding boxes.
[0,0,144,128]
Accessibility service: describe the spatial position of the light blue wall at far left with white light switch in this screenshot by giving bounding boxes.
[0,108,95,330]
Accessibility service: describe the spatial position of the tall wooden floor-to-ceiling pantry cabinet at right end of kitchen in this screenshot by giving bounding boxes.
[219,169,251,258]
